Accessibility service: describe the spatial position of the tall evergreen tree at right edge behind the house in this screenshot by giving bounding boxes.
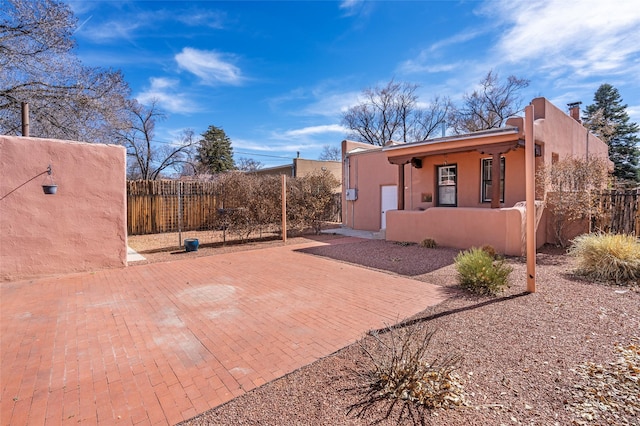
[582,83,640,182]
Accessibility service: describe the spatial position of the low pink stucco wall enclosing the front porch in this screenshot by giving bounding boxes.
[386,207,524,256]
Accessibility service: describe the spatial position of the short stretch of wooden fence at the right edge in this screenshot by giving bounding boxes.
[591,189,640,237]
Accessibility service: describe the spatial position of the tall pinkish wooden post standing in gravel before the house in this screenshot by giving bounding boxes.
[524,105,536,293]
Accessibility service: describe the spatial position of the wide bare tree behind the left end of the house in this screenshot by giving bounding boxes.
[342,80,452,145]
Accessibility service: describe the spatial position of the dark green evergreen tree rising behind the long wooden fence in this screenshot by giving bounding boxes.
[196,126,235,174]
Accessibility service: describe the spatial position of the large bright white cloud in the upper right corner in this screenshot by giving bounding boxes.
[482,0,640,77]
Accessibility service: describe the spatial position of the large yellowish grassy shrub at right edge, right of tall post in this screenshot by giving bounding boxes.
[569,234,640,285]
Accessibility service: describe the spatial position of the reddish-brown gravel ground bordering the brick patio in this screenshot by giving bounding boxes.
[134,236,640,425]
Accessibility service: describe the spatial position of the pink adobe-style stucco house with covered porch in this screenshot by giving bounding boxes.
[342,98,608,256]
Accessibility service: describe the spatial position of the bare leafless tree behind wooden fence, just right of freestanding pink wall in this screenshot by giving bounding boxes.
[118,100,196,180]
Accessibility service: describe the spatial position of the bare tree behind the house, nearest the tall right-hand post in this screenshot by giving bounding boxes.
[449,70,529,134]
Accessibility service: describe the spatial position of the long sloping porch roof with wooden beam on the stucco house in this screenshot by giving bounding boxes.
[382,126,524,165]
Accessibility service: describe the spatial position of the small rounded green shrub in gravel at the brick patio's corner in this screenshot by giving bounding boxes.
[455,247,512,295]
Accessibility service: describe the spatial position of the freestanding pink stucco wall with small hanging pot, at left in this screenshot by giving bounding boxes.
[0,136,127,280]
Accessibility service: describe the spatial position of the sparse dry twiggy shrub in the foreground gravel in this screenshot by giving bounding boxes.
[348,325,467,424]
